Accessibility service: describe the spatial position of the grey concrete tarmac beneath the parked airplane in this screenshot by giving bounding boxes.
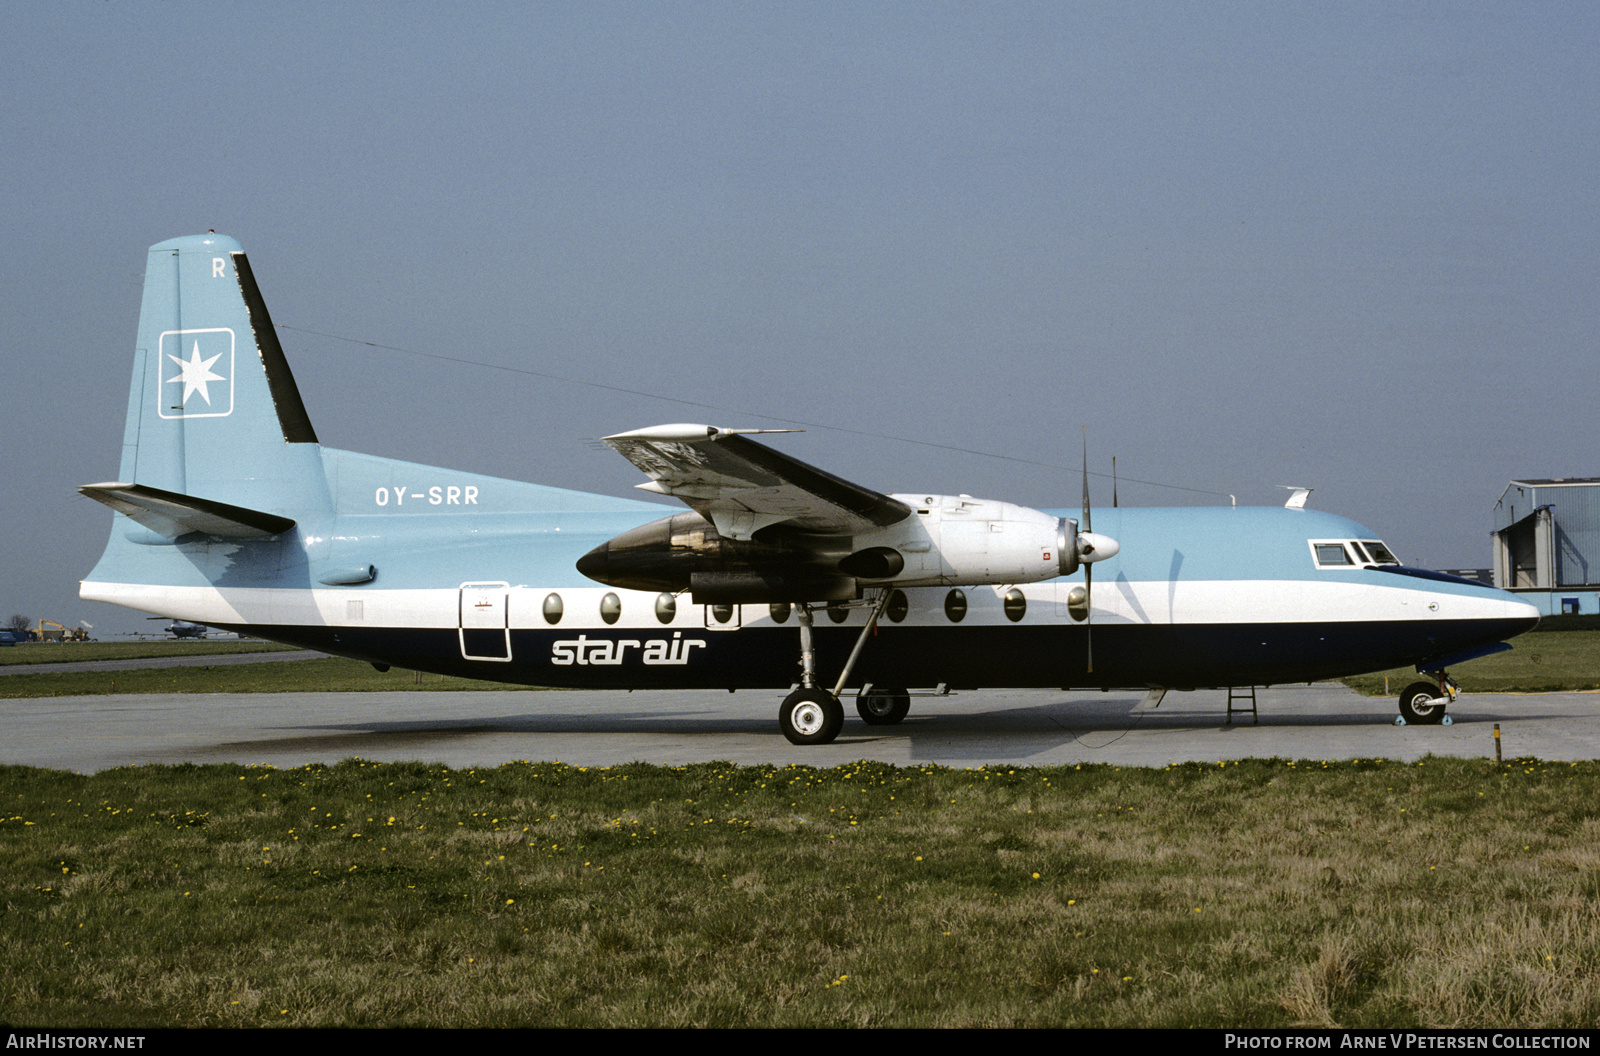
[12,683,1600,773]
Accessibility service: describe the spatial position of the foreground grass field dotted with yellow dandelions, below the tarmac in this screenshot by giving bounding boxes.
[0,758,1600,1027]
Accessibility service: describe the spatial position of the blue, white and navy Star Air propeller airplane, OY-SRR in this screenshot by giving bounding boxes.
[82,234,1538,744]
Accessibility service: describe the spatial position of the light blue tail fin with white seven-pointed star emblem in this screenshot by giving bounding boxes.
[106,234,326,512]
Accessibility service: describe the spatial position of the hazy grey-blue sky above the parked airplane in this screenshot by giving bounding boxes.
[0,0,1600,629]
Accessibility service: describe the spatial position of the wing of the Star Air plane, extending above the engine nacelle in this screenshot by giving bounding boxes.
[605,426,910,539]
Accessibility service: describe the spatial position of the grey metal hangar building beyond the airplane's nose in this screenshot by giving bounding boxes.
[1493,477,1600,616]
